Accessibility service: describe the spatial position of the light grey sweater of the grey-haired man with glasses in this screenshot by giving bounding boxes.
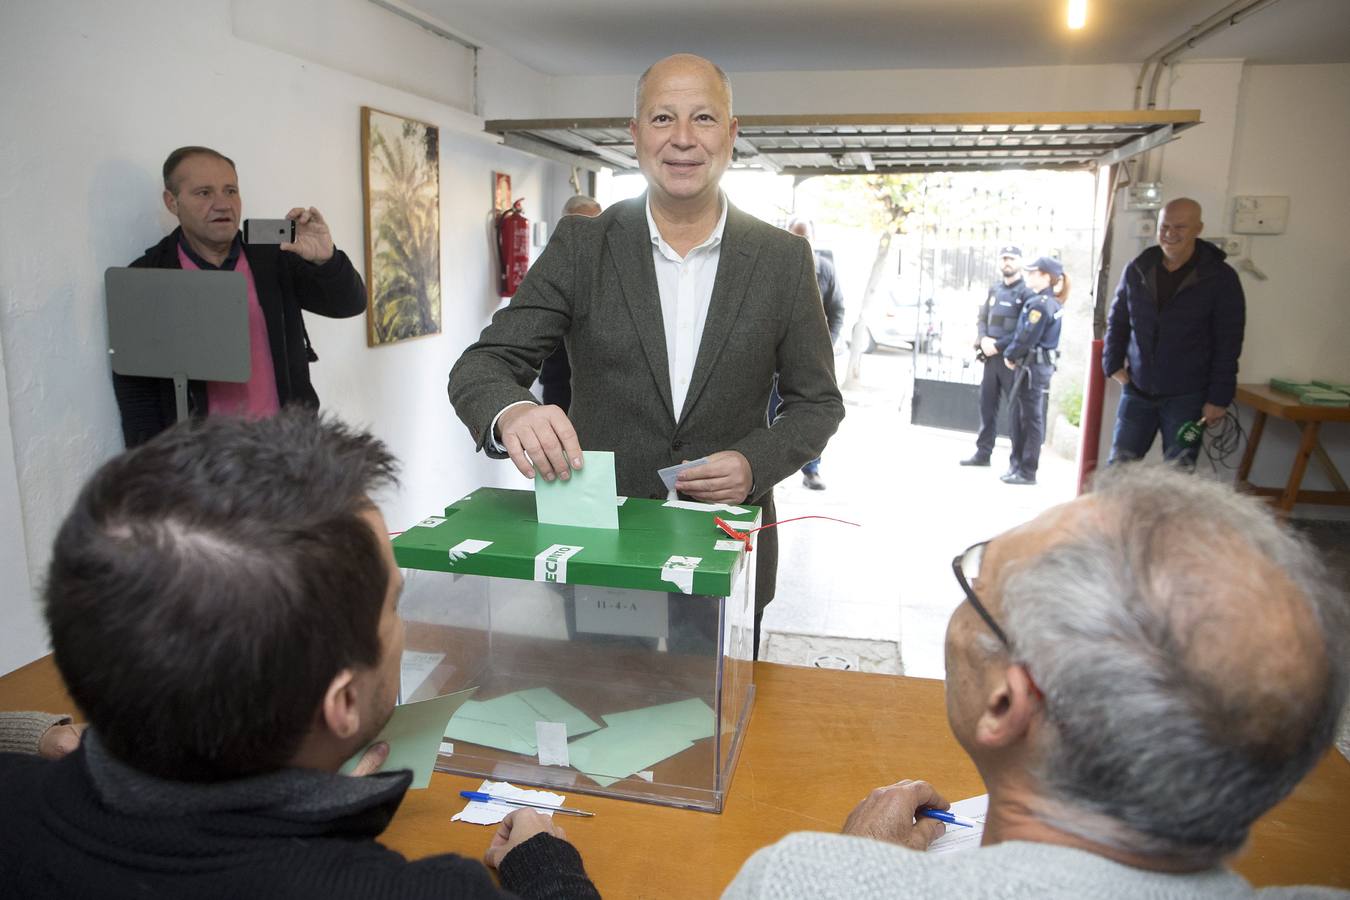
[722,831,1350,900]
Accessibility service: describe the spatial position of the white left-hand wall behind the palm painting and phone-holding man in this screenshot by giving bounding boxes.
[0,0,566,672]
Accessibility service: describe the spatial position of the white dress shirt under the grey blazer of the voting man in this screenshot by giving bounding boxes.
[487,196,726,452]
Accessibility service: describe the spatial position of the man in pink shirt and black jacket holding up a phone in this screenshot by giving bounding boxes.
[112,147,366,448]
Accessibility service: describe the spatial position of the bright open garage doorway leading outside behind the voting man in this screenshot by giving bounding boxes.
[597,169,1100,677]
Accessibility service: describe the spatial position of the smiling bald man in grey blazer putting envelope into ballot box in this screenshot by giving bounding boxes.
[450,54,844,649]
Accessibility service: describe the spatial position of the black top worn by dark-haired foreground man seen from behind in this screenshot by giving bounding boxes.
[0,733,599,900]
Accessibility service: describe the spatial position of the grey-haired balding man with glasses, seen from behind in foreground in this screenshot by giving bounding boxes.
[725,467,1350,899]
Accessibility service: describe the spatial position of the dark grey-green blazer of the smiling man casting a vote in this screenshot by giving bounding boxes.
[448,194,844,507]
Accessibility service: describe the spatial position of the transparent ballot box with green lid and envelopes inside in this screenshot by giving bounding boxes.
[394,488,761,812]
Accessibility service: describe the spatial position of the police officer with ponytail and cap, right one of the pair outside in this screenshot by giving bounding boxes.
[1003,256,1069,484]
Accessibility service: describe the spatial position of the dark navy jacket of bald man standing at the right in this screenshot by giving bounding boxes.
[1102,240,1246,406]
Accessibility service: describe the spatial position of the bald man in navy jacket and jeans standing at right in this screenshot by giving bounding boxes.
[1102,197,1246,467]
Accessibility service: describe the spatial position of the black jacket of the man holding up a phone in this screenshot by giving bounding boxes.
[112,228,366,447]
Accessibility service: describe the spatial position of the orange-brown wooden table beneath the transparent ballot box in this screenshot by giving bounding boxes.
[0,657,1350,900]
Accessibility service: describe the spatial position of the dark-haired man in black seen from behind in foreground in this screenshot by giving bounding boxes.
[0,409,598,899]
